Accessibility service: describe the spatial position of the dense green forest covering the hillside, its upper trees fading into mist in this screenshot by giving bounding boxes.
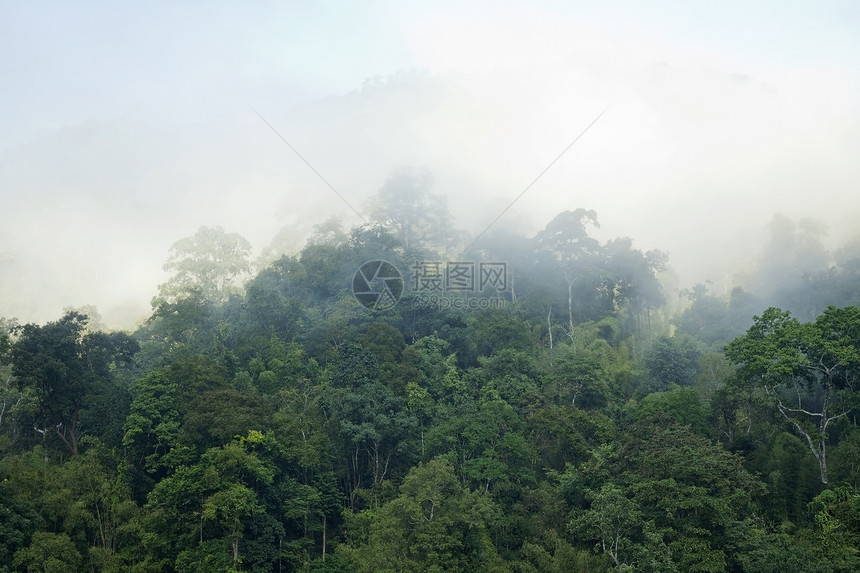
[0,170,860,573]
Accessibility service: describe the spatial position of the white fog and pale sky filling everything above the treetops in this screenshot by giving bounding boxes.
[0,2,860,328]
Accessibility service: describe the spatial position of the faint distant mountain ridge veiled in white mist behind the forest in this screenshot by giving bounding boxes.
[0,66,857,327]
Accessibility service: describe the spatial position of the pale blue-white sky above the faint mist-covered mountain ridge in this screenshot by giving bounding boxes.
[0,0,860,147]
